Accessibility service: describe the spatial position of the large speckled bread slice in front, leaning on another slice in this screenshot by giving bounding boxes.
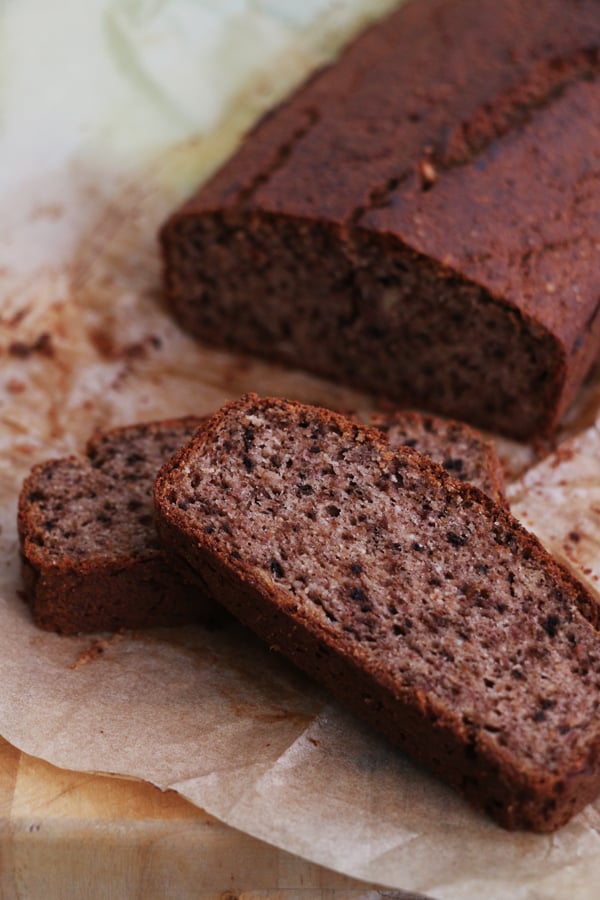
[155,396,600,831]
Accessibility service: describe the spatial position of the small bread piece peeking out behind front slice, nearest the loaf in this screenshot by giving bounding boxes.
[366,410,506,505]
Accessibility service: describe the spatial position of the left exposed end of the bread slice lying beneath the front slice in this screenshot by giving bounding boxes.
[18,417,217,634]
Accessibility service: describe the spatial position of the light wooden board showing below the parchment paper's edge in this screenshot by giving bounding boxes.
[0,738,398,900]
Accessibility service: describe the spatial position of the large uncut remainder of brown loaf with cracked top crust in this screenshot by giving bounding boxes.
[161,0,600,438]
